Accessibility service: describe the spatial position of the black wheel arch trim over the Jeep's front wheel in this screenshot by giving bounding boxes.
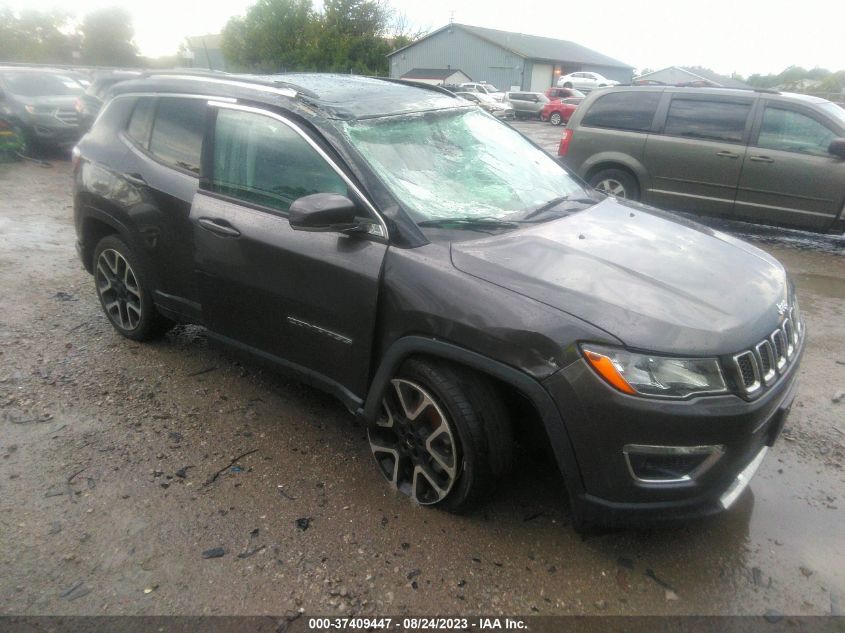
[356,336,584,512]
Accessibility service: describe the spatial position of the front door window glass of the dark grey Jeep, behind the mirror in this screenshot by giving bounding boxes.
[211,108,349,214]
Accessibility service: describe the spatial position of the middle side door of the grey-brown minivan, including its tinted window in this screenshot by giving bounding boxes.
[643,93,755,215]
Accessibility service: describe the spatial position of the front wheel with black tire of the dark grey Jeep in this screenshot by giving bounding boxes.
[368,359,513,512]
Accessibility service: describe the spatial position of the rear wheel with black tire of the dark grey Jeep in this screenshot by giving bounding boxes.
[92,235,173,341]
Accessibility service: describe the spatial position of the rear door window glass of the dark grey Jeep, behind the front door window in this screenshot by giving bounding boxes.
[150,97,208,174]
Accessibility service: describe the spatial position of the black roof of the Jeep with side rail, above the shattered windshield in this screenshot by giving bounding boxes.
[113,71,465,119]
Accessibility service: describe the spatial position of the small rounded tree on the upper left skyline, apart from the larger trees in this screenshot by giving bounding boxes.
[79,7,138,66]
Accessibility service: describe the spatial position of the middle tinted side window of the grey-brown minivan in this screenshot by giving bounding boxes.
[665,99,751,143]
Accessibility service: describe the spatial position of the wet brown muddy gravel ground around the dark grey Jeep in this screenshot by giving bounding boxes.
[0,146,845,615]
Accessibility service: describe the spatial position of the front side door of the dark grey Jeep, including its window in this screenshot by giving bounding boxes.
[191,104,387,402]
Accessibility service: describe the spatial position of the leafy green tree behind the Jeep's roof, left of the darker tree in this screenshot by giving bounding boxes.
[222,0,316,72]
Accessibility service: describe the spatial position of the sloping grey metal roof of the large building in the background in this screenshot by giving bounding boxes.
[388,23,633,68]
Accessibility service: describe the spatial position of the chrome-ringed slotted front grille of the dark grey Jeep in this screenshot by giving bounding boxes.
[732,305,803,395]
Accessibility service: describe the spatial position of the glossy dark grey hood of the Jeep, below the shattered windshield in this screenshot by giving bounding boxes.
[451,198,788,355]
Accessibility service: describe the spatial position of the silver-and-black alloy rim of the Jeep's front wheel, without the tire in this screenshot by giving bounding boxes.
[368,378,459,505]
